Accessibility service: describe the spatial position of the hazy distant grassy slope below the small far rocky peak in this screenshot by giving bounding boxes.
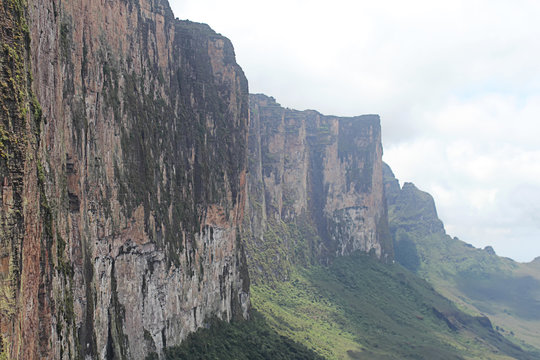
[398,234,540,348]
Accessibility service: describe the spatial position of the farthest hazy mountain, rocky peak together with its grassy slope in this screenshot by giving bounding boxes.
[389,179,540,348]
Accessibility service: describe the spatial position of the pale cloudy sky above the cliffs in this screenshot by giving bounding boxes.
[170,0,540,262]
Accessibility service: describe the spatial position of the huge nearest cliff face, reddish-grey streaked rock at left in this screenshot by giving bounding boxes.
[0,0,249,359]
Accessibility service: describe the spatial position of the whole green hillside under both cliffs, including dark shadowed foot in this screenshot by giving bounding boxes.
[162,254,540,360]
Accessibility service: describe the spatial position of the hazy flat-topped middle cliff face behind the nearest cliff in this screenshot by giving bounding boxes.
[245,95,392,279]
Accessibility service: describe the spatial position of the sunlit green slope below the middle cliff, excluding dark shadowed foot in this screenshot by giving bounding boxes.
[252,256,535,359]
